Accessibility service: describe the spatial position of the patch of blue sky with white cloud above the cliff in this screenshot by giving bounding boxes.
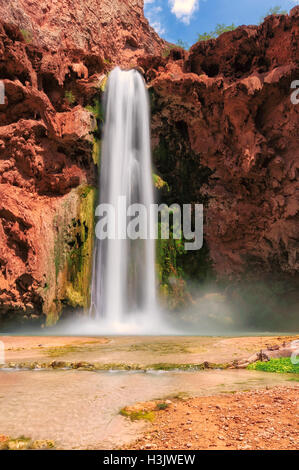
[144,0,299,46]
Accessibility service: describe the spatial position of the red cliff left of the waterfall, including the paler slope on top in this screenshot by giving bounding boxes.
[0,0,164,324]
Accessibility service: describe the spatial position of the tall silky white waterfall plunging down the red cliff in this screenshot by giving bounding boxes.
[91,67,157,325]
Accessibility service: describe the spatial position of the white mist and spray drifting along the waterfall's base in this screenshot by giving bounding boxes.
[56,281,299,336]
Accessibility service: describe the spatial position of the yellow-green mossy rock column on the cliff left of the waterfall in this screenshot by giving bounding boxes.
[41,185,97,326]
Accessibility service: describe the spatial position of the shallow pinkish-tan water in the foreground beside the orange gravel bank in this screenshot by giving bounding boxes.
[0,370,295,449]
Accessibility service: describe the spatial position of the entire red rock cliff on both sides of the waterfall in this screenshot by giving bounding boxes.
[0,0,299,324]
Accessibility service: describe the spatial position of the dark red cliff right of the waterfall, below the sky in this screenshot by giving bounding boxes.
[139,7,299,279]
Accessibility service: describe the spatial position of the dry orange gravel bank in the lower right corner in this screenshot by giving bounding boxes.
[125,387,299,450]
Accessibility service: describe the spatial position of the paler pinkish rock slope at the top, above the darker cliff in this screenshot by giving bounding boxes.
[0,0,164,65]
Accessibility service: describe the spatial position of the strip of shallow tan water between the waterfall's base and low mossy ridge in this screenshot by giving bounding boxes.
[0,336,299,365]
